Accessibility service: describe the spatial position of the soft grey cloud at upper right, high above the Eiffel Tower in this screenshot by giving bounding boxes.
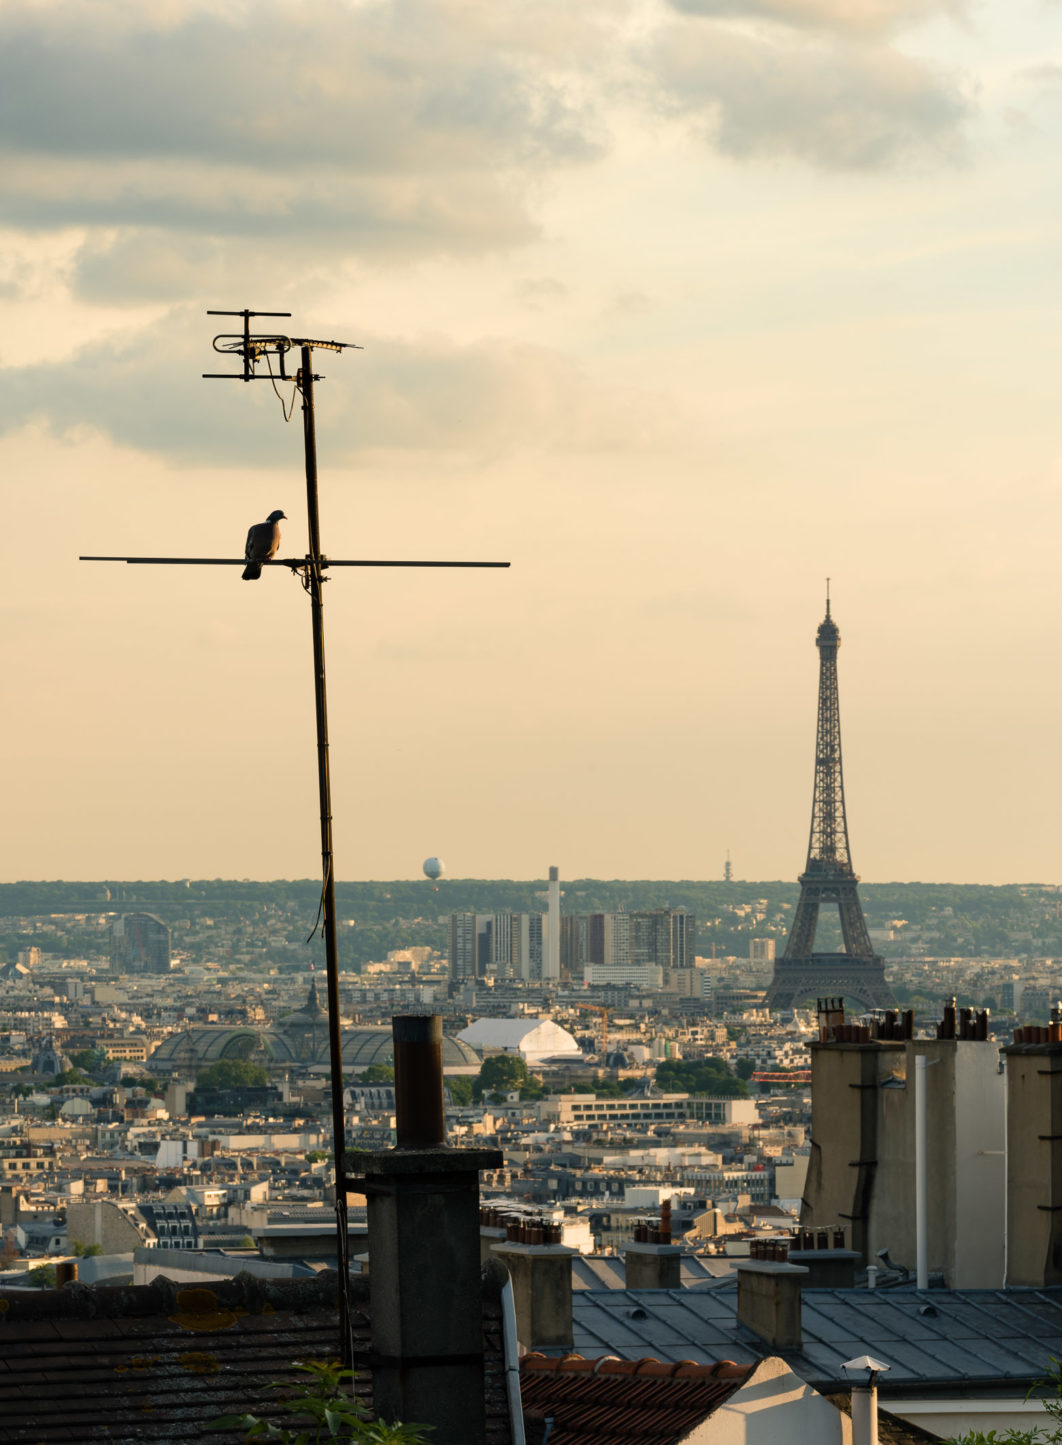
[650,22,970,171]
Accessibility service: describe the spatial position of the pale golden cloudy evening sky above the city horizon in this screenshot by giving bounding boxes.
[0,0,1062,883]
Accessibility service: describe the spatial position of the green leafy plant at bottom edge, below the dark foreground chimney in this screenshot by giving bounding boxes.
[207,1360,431,1445]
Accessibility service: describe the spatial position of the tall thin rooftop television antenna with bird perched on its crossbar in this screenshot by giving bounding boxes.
[78,309,509,1368]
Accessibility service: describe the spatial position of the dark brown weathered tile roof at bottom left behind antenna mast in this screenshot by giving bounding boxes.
[0,1270,511,1445]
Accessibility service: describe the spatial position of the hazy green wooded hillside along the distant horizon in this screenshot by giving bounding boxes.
[8,879,1062,965]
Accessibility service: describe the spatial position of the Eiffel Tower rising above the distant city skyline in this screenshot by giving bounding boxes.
[767,587,896,1009]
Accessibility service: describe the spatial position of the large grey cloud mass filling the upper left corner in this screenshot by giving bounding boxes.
[0,0,603,262]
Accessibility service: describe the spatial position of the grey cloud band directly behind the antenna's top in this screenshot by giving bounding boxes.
[0,311,673,467]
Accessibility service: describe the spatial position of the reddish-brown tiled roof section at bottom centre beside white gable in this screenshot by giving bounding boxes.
[520,1354,754,1445]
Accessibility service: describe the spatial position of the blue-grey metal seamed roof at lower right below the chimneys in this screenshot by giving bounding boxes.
[572,1280,1062,1394]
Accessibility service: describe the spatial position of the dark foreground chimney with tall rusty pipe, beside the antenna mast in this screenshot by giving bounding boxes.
[345,1014,504,1445]
